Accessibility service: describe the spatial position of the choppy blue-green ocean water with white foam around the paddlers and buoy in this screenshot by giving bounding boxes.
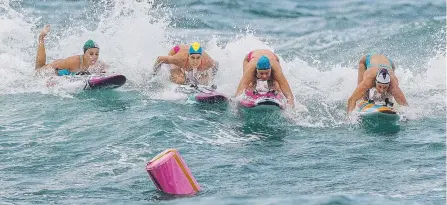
[0,0,446,205]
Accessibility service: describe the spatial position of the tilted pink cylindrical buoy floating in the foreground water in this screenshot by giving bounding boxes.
[146,149,200,195]
